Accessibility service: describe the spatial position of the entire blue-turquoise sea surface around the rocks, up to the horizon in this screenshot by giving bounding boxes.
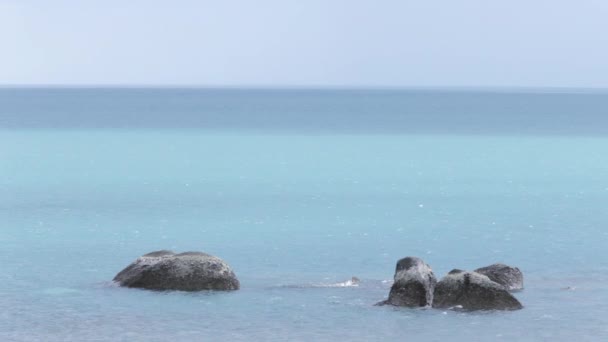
[0,88,608,342]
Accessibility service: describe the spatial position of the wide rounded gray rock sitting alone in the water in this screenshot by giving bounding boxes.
[114,250,240,291]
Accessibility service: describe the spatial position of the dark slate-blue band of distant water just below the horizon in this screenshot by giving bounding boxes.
[0,88,608,135]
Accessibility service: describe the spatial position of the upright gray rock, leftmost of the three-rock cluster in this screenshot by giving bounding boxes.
[378,257,437,307]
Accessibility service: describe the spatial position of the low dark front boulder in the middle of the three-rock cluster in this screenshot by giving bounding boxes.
[433,270,523,311]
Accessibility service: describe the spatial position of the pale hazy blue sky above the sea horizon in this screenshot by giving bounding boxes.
[0,0,608,87]
